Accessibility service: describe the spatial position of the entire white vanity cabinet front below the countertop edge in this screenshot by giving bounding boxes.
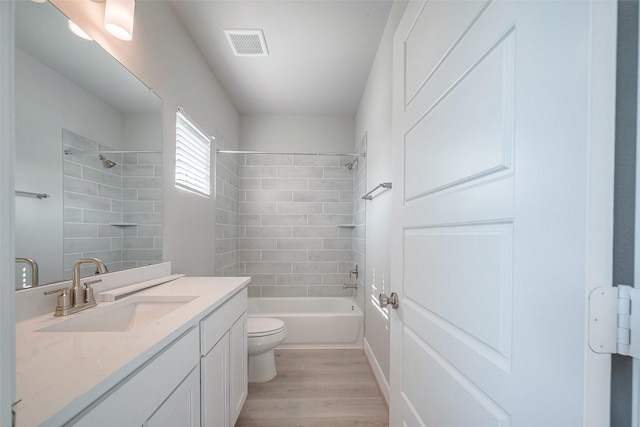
[65,288,248,427]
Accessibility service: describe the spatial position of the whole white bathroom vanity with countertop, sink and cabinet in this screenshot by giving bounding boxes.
[16,277,249,427]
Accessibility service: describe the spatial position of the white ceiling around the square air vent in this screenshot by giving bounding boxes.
[172,0,392,114]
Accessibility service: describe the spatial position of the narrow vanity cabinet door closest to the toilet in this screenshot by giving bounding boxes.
[229,312,249,425]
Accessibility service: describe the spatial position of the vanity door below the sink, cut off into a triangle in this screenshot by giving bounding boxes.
[143,368,200,427]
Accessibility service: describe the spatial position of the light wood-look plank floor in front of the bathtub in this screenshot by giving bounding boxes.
[236,350,389,427]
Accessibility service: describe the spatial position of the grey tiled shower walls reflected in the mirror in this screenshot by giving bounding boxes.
[63,130,162,279]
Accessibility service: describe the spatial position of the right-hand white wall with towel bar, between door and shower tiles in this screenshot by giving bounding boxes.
[356,2,406,402]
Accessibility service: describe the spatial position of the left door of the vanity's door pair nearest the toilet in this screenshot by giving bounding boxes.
[200,332,233,427]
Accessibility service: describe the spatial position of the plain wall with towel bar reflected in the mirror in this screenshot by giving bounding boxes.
[15,49,123,283]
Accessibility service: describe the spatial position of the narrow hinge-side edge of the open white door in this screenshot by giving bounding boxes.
[584,0,618,427]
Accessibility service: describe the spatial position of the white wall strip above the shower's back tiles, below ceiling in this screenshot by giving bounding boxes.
[240,114,355,153]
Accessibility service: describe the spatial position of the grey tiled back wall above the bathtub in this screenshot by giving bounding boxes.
[238,154,356,297]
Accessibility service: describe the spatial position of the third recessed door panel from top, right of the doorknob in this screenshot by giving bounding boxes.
[404,223,513,360]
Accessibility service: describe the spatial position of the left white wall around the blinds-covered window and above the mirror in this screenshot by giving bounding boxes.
[52,0,239,276]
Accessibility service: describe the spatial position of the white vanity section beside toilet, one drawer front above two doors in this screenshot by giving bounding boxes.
[200,289,248,427]
